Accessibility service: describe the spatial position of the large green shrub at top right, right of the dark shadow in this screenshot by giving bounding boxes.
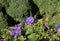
[33,0,60,16]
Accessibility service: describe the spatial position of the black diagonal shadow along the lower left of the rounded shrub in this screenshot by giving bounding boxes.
[1,7,19,26]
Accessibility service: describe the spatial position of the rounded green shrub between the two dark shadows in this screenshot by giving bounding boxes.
[6,0,28,22]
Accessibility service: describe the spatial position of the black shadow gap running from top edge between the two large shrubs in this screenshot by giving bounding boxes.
[28,0,43,19]
